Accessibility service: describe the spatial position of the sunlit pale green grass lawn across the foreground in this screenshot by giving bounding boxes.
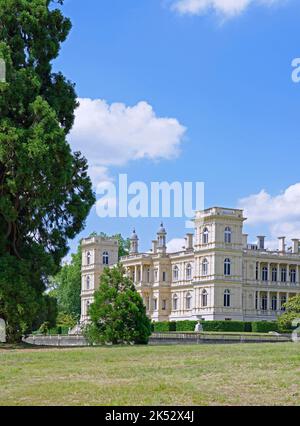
[0,343,300,405]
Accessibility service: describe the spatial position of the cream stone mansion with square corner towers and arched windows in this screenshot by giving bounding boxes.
[82,207,300,321]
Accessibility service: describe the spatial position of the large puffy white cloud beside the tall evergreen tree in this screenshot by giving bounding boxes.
[70,99,186,183]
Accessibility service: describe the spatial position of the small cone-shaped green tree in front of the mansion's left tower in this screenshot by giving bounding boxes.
[84,265,151,344]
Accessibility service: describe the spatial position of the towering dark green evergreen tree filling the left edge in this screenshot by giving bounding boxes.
[0,0,94,340]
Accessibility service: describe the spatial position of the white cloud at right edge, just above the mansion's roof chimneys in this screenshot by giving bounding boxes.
[238,183,300,244]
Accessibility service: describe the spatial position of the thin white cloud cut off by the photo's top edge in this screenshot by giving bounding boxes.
[172,0,286,17]
